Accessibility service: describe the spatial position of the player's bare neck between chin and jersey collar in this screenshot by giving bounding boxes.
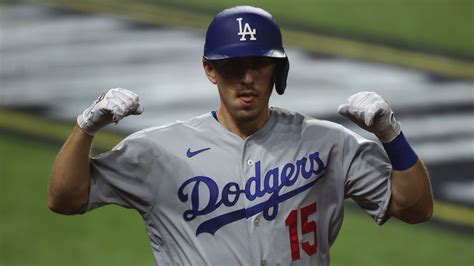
[217,108,271,139]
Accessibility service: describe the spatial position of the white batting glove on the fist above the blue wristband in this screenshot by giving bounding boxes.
[337,91,401,143]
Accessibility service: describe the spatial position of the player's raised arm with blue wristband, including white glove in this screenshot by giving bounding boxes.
[338,92,433,223]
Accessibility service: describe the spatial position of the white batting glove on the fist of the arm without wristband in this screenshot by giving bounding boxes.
[77,88,143,136]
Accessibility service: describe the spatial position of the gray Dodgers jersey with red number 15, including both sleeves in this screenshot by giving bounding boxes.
[87,108,391,265]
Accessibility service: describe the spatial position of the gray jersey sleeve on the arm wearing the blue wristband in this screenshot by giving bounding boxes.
[343,132,392,224]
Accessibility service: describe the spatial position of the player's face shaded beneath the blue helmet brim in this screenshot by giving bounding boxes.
[204,57,275,123]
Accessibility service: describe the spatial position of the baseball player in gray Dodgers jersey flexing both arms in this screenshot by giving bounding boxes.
[49,6,433,265]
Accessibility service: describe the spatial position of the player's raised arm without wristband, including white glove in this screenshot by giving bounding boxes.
[48,88,143,214]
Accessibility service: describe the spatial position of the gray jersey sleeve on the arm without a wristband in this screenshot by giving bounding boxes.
[86,132,158,214]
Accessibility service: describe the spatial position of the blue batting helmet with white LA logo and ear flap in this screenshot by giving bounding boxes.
[204,6,290,94]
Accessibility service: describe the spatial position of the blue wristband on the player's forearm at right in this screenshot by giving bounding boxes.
[383,132,418,171]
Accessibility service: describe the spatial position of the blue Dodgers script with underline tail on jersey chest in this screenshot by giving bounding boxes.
[178,152,326,236]
